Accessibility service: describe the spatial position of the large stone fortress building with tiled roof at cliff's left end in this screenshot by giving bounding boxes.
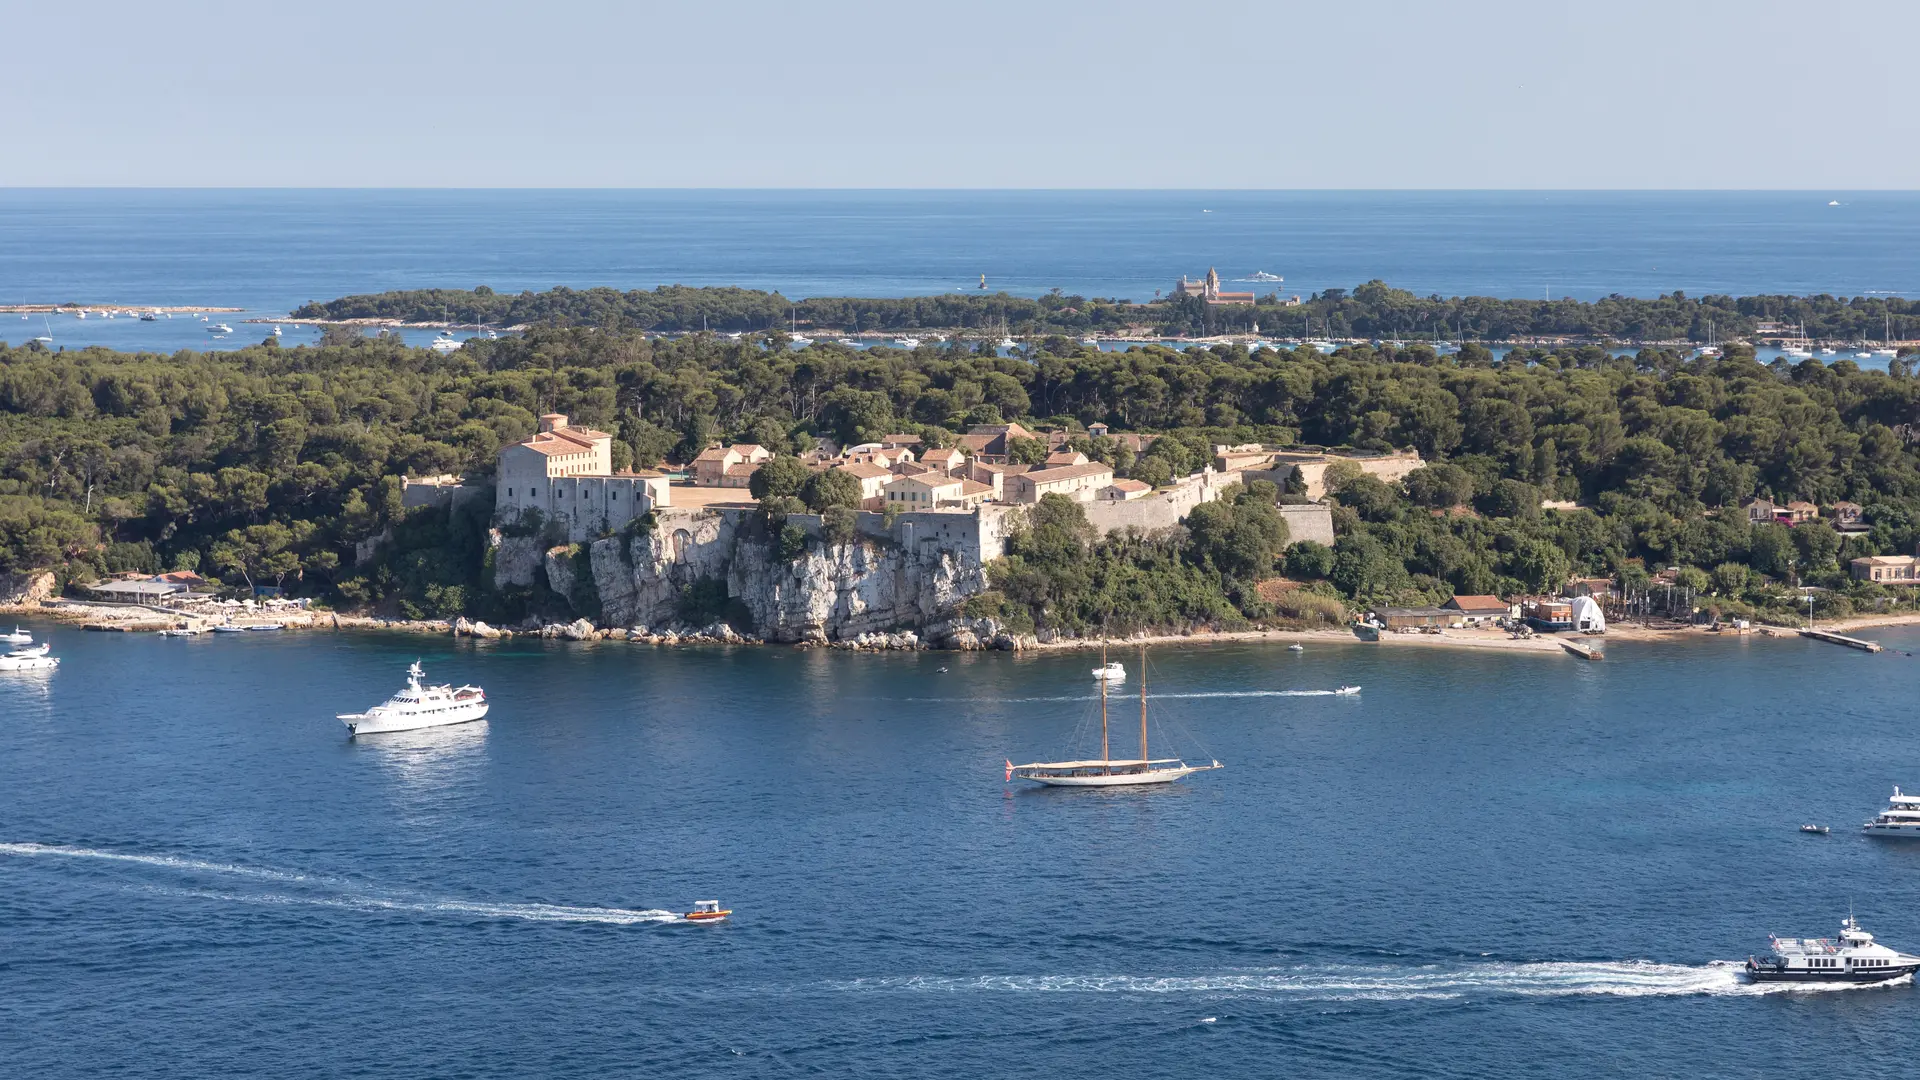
[493,413,672,544]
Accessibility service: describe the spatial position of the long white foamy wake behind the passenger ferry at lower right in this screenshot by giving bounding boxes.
[835,961,1912,1001]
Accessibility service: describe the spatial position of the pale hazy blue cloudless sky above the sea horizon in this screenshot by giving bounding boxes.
[0,0,1920,190]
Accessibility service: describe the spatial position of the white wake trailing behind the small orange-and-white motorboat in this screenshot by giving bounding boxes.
[0,844,685,926]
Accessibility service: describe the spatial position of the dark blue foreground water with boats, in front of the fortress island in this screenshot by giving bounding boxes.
[0,626,1920,1078]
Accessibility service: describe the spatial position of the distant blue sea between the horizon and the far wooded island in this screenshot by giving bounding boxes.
[0,188,1920,350]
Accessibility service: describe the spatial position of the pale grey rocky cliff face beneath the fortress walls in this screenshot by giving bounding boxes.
[493,513,987,642]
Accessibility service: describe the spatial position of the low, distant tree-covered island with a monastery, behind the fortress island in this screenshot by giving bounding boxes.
[294,281,1920,342]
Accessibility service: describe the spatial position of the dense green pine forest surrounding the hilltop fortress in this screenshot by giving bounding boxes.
[0,328,1920,630]
